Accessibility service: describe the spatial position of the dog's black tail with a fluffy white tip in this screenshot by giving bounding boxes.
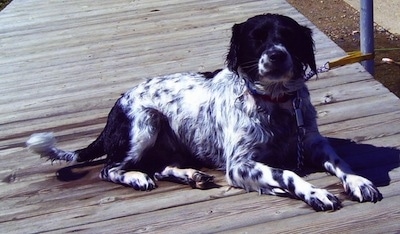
[26,132,105,162]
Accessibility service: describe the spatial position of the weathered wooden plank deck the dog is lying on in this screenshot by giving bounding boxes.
[0,0,400,233]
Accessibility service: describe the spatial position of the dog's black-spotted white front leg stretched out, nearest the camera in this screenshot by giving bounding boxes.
[227,161,341,211]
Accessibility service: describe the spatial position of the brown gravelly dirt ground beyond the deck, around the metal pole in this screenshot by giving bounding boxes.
[0,0,400,97]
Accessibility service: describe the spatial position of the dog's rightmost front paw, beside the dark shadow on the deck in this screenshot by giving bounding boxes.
[343,175,383,203]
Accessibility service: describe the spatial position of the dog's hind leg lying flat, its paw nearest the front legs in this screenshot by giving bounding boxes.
[154,166,215,189]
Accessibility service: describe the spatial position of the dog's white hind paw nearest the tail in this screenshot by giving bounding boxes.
[122,171,157,191]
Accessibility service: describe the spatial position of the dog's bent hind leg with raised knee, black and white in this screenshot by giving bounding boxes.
[100,108,170,191]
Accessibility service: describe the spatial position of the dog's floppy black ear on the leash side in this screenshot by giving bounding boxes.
[301,26,317,73]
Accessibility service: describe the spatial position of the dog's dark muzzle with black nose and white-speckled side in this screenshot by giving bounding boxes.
[258,45,293,80]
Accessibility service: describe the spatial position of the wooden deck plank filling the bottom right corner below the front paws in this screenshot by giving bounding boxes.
[222,196,400,233]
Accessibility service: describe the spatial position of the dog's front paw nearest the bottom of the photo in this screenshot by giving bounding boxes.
[305,188,342,211]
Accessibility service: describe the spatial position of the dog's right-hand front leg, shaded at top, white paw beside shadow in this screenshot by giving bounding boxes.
[306,134,382,203]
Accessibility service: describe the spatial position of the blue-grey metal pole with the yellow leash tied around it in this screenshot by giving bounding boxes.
[360,0,375,75]
